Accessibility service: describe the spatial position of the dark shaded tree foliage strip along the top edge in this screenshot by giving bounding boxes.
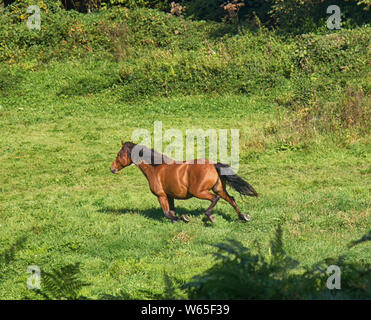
[4,0,371,33]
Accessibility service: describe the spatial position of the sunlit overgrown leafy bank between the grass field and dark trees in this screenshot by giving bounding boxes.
[0,1,371,135]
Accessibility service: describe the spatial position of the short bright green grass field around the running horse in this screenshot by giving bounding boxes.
[0,58,370,299]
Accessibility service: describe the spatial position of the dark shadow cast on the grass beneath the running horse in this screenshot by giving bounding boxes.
[98,206,233,222]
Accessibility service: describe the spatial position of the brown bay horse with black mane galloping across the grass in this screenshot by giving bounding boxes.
[110,142,258,222]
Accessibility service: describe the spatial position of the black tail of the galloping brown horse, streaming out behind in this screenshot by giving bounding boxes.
[215,162,258,197]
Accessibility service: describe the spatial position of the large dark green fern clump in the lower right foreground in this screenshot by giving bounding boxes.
[183,227,371,300]
